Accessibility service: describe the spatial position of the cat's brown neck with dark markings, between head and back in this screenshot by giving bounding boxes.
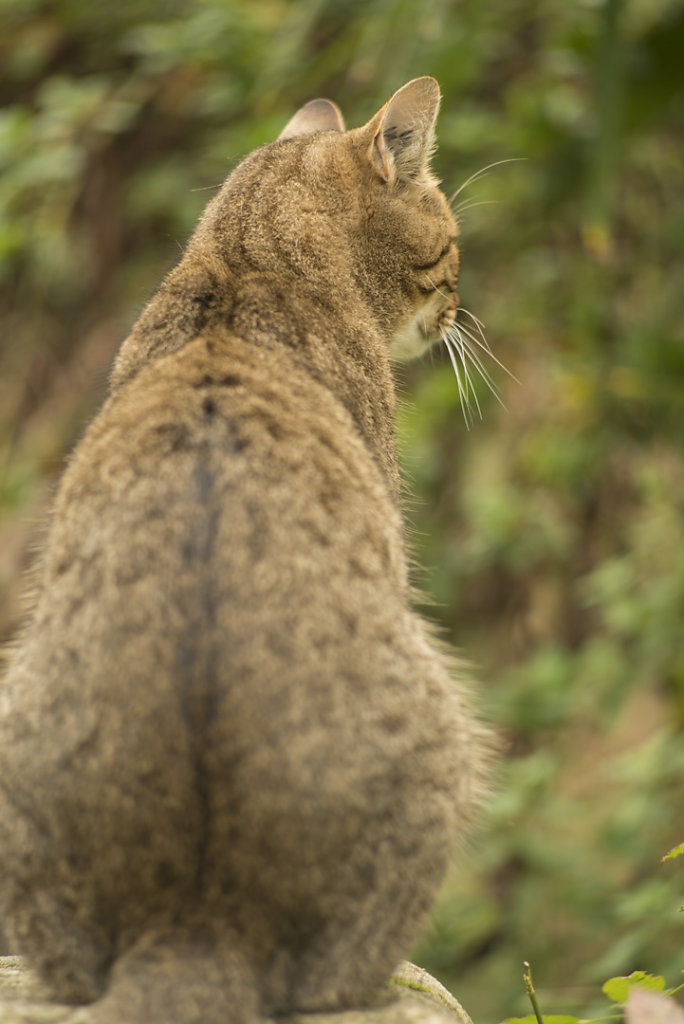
[111,253,400,502]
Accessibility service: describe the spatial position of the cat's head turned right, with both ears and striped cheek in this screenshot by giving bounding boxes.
[205,77,459,358]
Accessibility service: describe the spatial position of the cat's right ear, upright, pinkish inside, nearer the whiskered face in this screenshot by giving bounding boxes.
[368,75,440,181]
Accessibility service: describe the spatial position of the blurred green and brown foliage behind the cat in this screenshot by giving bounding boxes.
[0,0,684,1024]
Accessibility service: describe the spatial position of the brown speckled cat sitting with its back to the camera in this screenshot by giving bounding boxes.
[0,77,488,1024]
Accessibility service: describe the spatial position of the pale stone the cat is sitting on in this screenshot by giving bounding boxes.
[0,956,472,1024]
